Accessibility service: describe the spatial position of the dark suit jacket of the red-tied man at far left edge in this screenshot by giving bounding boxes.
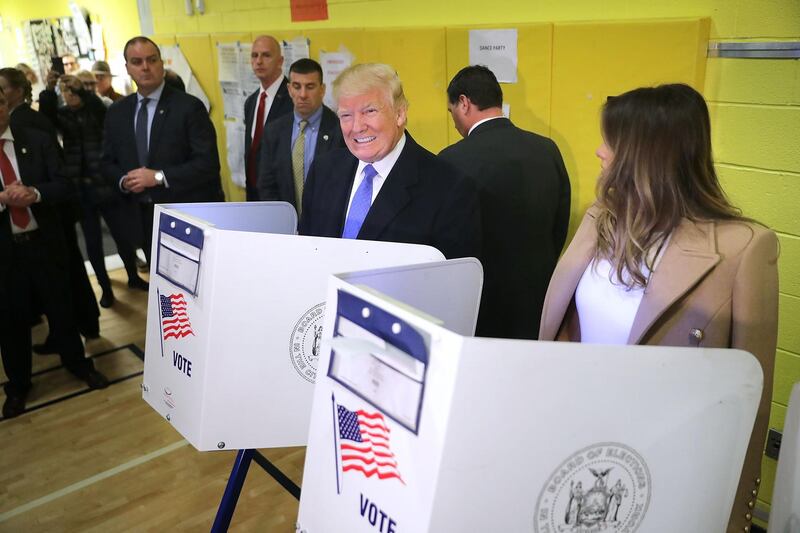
[0,127,72,282]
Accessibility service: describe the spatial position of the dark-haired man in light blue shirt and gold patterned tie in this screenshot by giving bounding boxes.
[258,58,344,208]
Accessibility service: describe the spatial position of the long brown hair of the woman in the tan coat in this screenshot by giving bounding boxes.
[596,84,743,288]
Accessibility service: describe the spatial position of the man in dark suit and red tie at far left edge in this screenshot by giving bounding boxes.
[0,90,108,418]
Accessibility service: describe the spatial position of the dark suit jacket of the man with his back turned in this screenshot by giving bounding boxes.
[439,118,570,339]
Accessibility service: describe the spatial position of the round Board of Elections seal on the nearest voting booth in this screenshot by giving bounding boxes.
[533,442,651,533]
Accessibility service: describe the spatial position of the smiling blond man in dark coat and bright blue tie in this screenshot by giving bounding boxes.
[300,63,480,258]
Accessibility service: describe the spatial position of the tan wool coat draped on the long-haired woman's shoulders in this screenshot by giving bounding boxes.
[539,208,778,533]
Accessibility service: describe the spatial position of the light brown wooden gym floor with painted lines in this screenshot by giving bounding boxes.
[0,270,305,533]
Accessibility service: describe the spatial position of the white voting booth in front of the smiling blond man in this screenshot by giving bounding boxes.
[142,202,450,450]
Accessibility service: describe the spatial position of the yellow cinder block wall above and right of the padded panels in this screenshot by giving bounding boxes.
[0,0,800,524]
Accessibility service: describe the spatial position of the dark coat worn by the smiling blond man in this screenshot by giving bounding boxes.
[300,133,481,258]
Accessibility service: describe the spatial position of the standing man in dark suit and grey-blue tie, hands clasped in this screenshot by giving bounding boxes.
[101,36,225,261]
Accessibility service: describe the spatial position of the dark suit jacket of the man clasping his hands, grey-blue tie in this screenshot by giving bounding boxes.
[100,85,225,204]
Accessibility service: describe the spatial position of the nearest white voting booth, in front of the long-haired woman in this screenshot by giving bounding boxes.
[297,261,763,533]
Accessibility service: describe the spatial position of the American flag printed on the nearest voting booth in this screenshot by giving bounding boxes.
[336,405,404,483]
